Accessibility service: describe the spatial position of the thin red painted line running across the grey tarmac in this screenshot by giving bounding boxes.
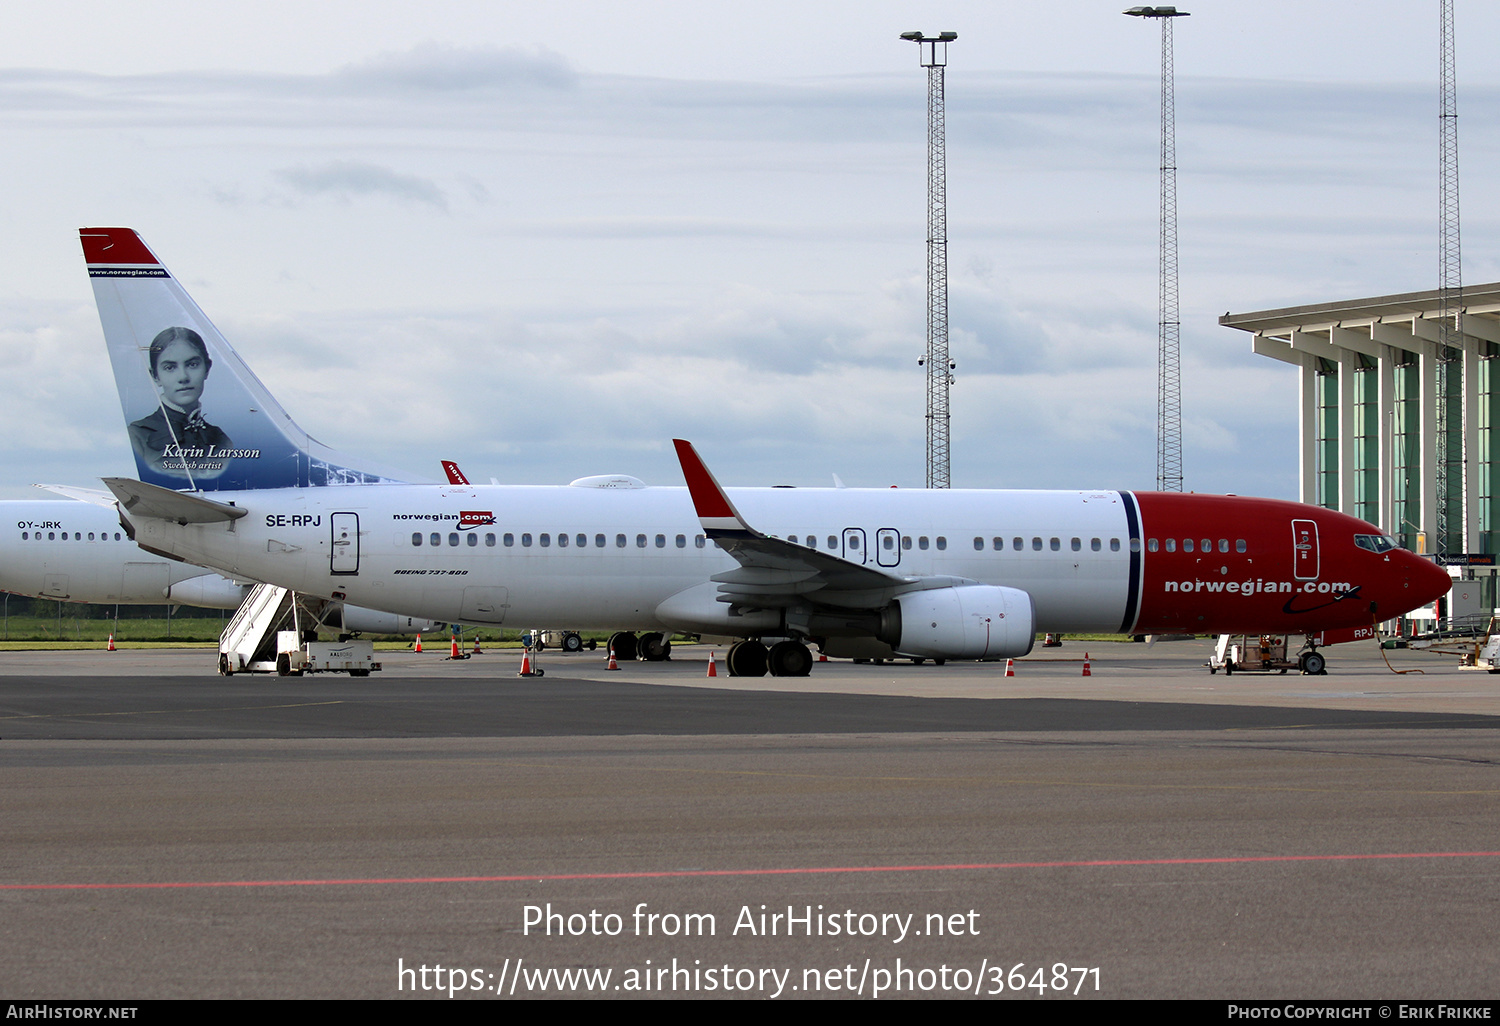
[0,852,1500,891]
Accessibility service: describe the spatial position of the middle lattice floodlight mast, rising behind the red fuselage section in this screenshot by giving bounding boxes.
[1124,8,1188,492]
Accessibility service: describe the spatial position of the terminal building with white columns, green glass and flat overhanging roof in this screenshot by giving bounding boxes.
[1220,284,1500,615]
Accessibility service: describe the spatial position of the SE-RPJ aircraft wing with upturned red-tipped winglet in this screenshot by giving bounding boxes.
[672,438,974,609]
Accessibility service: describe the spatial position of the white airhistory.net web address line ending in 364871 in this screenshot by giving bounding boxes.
[396,959,1100,998]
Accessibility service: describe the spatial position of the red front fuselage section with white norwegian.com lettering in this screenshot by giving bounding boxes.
[1136,492,1449,635]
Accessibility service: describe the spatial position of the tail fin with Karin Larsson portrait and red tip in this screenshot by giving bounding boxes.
[78,228,411,492]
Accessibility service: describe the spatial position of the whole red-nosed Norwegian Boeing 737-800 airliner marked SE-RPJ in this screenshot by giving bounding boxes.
[81,228,1449,675]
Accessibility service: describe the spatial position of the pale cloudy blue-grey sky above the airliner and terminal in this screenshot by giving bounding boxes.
[0,0,1500,498]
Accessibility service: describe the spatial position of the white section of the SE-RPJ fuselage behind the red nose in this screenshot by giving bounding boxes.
[132,485,1130,632]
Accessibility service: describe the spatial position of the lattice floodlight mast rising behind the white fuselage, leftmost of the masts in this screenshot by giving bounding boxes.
[902,32,959,488]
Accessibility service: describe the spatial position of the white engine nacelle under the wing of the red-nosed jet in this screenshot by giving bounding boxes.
[881,585,1037,659]
